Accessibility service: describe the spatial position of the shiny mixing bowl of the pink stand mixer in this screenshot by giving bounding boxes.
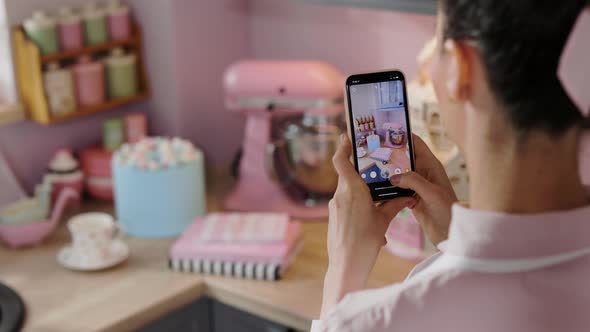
[269,115,345,205]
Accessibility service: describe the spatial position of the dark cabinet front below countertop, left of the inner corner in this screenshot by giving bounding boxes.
[138,298,213,332]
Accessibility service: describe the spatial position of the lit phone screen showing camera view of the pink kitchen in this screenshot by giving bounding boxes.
[350,80,412,190]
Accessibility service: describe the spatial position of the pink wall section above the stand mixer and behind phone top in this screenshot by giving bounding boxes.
[250,0,435,78]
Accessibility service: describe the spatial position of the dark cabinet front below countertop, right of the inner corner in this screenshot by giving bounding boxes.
[213,301,292,332]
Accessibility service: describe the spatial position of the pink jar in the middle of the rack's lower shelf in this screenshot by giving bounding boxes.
[74,56,105,107]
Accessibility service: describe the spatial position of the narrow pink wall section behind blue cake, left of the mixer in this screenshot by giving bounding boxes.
[174,0,249,167]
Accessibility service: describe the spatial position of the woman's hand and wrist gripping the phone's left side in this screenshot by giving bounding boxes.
[322,135,417,315]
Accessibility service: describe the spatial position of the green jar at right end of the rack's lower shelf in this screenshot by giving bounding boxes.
[105,48,139,99]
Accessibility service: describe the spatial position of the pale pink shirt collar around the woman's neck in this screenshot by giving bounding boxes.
[444,204,590,259]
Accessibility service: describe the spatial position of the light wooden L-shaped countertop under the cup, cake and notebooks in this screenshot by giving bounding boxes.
[0,198,414,332]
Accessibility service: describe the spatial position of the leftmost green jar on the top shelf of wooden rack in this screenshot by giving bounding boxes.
[23,11,59,55]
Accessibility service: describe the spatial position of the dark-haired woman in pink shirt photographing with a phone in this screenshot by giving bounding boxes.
[312,0,590,331]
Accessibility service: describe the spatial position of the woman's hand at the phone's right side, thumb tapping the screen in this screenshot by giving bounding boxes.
[391,135,457,245]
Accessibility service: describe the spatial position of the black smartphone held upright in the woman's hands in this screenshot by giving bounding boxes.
[346,70,416,201]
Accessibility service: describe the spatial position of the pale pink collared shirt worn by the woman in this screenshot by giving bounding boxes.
[312,205,590,332]
